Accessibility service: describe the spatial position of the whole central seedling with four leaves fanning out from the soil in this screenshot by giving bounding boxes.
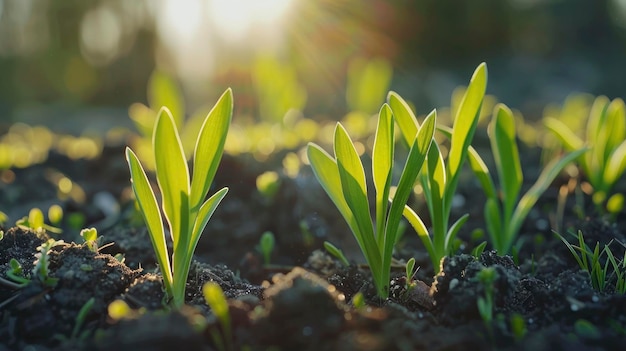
[307,104,436,299]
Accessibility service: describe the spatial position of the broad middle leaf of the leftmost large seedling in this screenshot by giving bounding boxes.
[152,108,189,248]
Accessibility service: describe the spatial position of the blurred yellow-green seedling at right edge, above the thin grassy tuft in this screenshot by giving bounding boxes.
[544,96,626,212]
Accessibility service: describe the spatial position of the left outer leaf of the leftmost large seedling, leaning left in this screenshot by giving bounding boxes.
[126,148,172,295]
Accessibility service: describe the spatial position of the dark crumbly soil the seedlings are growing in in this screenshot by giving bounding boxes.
[0,141,626,351]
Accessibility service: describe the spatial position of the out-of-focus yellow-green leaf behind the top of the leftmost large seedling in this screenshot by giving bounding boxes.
[148,71,185,128]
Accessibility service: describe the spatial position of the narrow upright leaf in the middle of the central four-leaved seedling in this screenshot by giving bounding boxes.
[372,104,394,248]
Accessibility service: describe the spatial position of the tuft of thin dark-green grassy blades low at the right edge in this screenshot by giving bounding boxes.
[555,230,626,294]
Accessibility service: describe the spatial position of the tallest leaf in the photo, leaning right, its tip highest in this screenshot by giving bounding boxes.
[448,62,487,178]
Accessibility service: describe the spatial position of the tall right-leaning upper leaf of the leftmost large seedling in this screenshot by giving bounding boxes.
[189,88,233,212]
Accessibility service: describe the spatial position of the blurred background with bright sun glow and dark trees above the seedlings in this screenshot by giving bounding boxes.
[0,0,626,133]
